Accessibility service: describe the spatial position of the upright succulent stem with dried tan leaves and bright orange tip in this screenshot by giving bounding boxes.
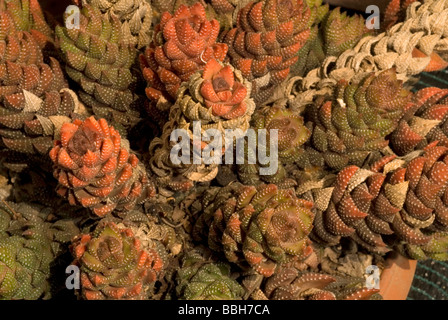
[150,59,255,187]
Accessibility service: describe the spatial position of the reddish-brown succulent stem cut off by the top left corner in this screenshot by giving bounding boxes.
[0,0,54,49]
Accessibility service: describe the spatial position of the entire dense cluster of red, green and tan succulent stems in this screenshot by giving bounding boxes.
[0,0,448,300]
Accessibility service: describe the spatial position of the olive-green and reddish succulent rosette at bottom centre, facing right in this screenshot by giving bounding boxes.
[193,183,314,277]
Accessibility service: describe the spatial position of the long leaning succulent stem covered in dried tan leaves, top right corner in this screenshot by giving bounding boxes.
[302,0,448,85]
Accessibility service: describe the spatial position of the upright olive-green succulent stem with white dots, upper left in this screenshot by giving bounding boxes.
[56,5,139,128]
